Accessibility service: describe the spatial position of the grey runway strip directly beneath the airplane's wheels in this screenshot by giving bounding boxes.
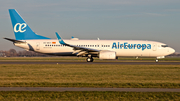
[0,61,180,65]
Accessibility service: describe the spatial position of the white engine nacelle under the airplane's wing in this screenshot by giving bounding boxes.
[99,51,116,59]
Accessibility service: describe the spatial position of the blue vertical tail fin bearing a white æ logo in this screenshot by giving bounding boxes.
[9,9,50,40]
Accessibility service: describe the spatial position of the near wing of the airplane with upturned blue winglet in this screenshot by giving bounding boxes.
[56,32,100,55]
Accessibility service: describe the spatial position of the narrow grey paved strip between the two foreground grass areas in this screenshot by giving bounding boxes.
[0,87,180,92]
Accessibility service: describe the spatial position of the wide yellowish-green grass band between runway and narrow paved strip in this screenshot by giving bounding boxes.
[0,64,180,88]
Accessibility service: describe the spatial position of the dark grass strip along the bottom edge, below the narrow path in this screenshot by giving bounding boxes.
[0,92,180,101]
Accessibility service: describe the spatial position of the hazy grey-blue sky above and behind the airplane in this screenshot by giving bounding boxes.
[0,0,180,52]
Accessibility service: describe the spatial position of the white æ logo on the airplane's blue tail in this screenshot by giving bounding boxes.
[14,23,27,33]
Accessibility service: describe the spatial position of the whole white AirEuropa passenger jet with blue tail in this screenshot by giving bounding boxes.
[4,9,175,62]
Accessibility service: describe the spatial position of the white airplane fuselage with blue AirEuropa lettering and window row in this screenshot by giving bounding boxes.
[15,39,175,58]
